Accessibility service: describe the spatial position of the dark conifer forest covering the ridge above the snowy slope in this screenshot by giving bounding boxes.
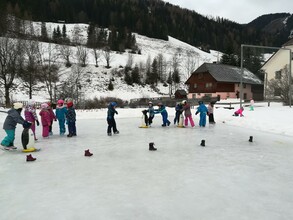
[0,0,292,53]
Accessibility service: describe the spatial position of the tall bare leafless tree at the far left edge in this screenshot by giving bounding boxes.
[0,37,23,107]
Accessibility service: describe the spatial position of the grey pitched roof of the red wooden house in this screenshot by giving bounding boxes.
[186,63,263,84]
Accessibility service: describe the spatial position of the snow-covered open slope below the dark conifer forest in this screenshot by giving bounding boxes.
[13,22,221,101]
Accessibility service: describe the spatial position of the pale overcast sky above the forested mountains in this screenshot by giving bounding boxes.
[165,0,293,24]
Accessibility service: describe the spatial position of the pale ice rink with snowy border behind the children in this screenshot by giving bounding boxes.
[0,104,293,220]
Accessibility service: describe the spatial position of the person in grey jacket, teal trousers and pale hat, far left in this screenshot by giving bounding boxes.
[1,102,31,150]
